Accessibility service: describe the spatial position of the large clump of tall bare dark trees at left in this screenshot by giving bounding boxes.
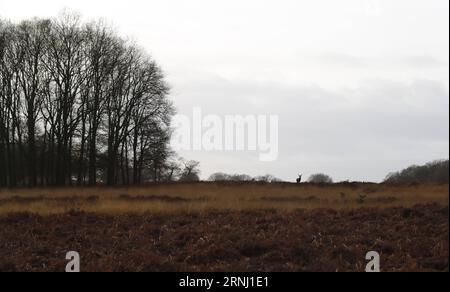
[0,14,178,187]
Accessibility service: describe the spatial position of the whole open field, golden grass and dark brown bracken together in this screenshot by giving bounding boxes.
[0,183,449,272]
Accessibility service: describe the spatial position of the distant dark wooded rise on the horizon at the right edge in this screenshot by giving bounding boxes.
[385,160,449,184]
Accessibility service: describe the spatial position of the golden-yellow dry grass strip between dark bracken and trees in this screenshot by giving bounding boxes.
[0,183,449,215]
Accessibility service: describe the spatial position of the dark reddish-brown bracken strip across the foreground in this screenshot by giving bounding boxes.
[0,205,449,272]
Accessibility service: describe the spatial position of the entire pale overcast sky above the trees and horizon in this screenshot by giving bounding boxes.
[0,0,449,181]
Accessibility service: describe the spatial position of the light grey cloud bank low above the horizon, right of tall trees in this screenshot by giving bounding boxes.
[171,75,449,181]
